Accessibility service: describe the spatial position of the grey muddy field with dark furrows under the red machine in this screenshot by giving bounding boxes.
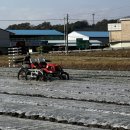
[0,68,130,130]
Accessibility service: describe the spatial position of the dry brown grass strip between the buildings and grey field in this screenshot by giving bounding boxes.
[0,50,130,70]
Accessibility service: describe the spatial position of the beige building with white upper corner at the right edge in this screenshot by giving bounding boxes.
[108,18,130,48]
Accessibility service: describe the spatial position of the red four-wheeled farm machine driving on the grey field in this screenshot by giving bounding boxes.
[18,58,69,81]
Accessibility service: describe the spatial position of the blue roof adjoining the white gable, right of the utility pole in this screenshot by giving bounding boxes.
[76,31,109,37]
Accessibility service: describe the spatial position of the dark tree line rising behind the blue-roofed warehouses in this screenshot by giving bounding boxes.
[7,19,118,33]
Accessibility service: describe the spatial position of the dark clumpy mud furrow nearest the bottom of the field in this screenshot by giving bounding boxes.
[0,112,119,130]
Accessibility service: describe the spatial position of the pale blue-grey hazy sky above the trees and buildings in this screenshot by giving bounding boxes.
[0,0,130,29]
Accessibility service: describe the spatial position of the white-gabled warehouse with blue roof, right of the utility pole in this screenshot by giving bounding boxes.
[68,31,109,49]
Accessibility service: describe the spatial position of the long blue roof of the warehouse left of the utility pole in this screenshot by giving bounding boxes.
[7,30,64,35]
